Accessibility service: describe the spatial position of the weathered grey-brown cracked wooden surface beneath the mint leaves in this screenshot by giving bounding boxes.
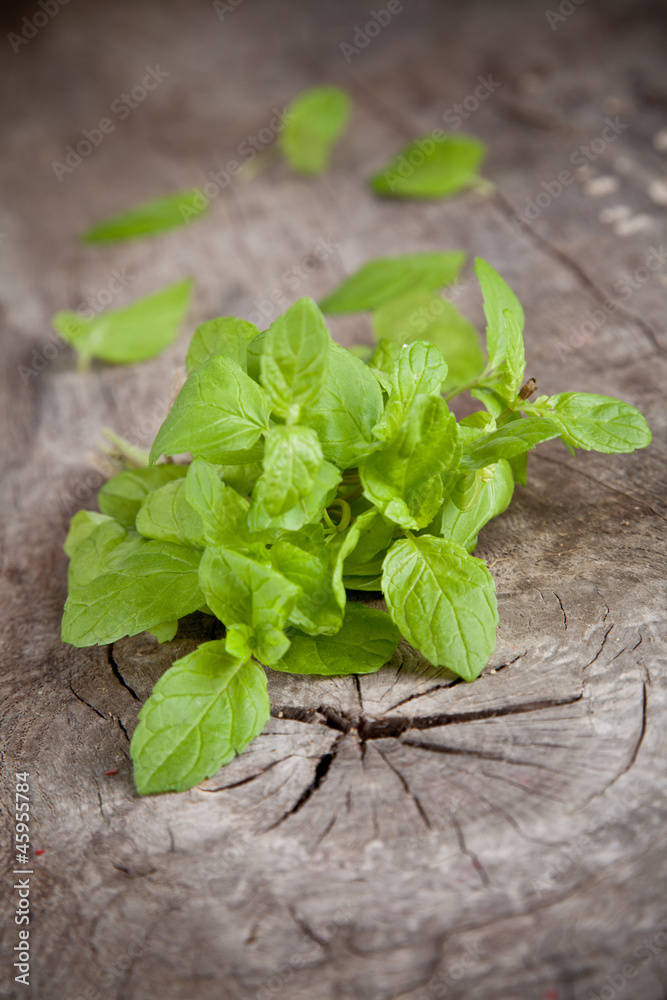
[0,0,667,1000]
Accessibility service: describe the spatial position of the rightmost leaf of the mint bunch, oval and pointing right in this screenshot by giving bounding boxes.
[545,392,652,454]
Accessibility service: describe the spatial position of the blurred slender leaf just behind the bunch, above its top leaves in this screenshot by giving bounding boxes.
[320,250,466,313]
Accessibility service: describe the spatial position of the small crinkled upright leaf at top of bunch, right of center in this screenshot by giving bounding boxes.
[373,340,447,440]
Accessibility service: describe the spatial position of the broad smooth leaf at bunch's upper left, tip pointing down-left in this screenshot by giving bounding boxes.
[151,357,269,465]
